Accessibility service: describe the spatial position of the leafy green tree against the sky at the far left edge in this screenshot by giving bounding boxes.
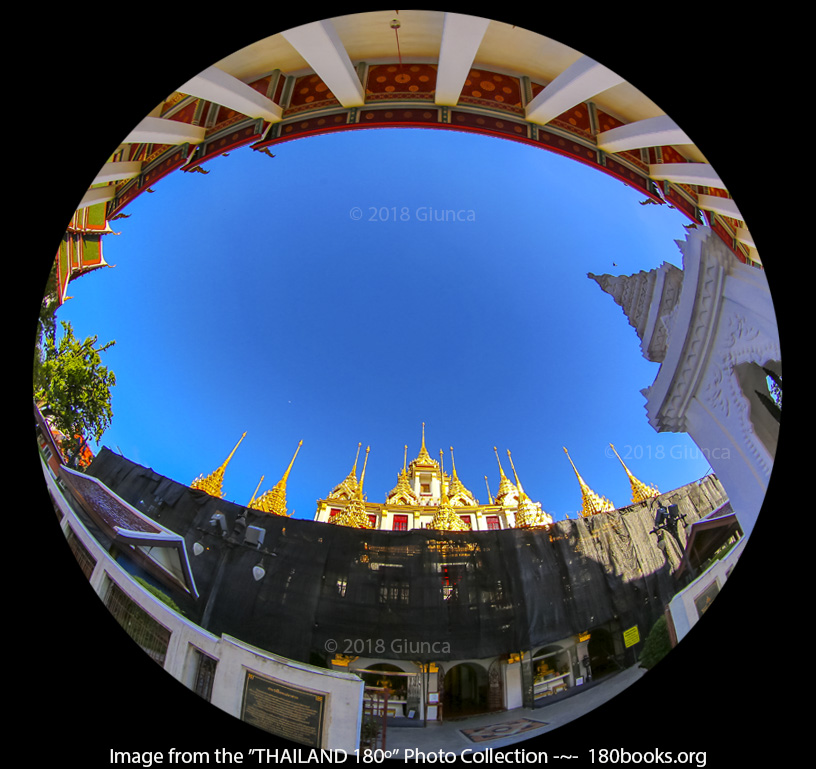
[34,321,116,466]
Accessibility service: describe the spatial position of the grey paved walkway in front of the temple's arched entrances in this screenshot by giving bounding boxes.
[385,666,646,758]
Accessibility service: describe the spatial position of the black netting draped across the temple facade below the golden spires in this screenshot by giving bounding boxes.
[88,449,726,662]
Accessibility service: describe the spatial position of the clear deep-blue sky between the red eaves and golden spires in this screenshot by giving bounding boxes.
[58,129,710,519]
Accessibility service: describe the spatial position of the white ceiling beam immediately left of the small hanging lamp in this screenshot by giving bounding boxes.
[281,19,365,107]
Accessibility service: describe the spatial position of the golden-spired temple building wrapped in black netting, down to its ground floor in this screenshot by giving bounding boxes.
[59,427,729,718]
